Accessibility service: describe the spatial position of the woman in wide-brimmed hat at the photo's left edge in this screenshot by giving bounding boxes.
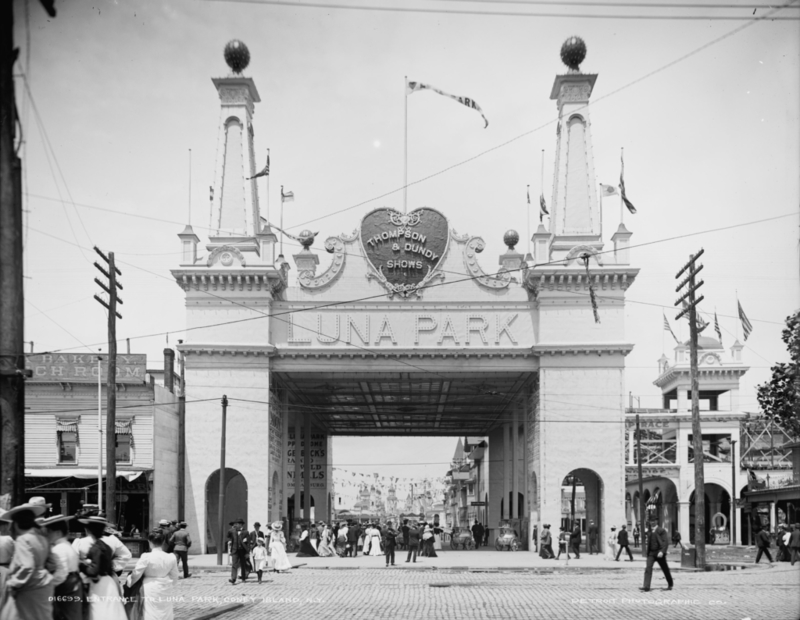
[0,498,53,620]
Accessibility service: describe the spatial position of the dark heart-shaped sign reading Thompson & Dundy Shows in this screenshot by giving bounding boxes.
[361,207,450,296]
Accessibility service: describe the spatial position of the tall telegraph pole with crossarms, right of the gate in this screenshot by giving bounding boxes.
[675,249,706,568]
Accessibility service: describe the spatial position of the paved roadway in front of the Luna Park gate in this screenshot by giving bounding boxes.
[166,551,800,620]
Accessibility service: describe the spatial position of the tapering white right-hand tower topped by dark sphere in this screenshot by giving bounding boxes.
[548,37,602,260]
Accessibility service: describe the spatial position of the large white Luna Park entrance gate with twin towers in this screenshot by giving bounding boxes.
[172,38,638,552]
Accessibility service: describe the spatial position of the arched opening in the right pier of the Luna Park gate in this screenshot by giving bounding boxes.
[561,468,607,551]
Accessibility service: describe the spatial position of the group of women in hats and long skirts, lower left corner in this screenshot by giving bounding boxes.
[0,497,178,620]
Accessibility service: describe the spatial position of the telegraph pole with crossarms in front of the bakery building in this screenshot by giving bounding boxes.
[94,246,122,524]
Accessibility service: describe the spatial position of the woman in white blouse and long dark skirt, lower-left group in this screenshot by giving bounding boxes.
[36,515,84,620]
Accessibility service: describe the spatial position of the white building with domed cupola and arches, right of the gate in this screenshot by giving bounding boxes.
[625,335,792,545]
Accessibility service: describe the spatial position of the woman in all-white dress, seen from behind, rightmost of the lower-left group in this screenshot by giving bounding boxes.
[127,529,178,620]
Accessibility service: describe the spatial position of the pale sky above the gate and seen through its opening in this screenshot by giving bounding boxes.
[14,0,800,486]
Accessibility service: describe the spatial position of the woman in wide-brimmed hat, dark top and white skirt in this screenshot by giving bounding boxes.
[78,517,128,620]
